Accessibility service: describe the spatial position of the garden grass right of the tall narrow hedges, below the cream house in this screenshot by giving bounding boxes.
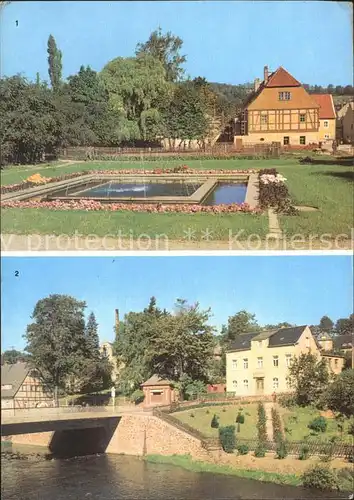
[280,407,353,444]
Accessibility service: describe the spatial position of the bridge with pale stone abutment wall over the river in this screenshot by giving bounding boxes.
[1,406,213,459]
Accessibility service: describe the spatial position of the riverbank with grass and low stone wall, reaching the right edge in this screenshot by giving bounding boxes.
[144,455,352,492]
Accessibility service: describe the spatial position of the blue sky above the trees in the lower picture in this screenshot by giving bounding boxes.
[1,256,353,351]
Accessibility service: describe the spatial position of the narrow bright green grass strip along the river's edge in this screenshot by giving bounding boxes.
[144,455,301,486]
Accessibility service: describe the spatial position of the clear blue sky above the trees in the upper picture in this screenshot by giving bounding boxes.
[1,1,353,85]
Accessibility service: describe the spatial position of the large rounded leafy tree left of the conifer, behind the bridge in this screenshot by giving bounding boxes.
[24,295,87,400]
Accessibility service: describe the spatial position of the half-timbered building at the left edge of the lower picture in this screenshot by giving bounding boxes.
[1,362,53,409]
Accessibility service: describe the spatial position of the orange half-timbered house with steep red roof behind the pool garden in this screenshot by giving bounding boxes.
[234,66,336,148]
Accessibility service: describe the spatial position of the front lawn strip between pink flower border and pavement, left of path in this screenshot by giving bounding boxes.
[1,208,268,241]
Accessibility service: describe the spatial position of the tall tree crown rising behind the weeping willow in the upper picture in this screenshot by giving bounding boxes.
[135,27,186,82]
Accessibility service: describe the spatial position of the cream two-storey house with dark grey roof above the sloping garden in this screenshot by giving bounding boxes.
[226,325,344,396]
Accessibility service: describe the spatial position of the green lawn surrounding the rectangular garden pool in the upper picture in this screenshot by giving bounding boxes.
[1,158,353,241]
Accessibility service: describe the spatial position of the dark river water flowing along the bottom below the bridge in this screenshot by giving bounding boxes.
[1,447,348,500]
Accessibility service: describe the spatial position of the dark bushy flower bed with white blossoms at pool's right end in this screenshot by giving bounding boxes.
[259,168,298,215]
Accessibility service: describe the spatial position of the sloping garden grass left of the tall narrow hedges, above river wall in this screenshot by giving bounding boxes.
[173,403,257,439]
